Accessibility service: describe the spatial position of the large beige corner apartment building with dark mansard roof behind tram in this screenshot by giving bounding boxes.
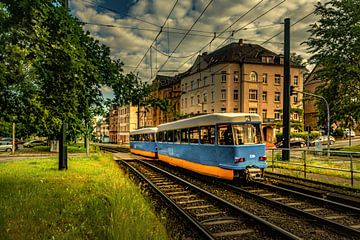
[180,40,303,142]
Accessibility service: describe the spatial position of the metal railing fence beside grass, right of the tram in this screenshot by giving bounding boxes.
[267,149,360,187]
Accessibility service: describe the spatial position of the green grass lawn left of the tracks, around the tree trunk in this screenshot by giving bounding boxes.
[0,155,168,240]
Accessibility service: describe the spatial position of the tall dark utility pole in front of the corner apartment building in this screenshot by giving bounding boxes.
[282,18,290,161]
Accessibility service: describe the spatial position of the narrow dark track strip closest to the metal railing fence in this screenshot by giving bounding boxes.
[265,172,360,208]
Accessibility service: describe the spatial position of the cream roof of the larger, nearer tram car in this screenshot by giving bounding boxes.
[158,113,261,131]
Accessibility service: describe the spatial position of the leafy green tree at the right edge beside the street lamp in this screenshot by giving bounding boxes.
[305,0,360,129]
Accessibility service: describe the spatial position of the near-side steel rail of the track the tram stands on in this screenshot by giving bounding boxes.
[224,183,360,238]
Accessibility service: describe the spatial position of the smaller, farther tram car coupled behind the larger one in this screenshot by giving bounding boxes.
[130,127,157,158]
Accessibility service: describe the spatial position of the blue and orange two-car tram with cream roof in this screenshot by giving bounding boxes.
[130,113,267,180]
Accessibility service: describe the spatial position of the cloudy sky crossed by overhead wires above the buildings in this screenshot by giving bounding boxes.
[71,0,324,80]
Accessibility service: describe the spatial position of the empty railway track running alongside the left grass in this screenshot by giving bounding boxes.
[121,158,301,239]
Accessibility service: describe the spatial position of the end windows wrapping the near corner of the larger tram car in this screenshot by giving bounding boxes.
[218,124,262,145]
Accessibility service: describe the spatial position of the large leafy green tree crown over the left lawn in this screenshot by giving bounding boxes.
[0,0,122,138]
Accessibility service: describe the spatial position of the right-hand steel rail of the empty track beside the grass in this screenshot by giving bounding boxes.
[141,158,301,239]
